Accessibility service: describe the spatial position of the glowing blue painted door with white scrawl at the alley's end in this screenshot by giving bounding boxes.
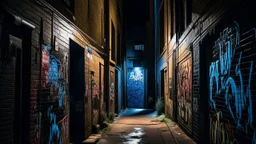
[127,68,144,108]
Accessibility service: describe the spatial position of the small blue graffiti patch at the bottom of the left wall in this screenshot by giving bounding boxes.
[47,106,62,144]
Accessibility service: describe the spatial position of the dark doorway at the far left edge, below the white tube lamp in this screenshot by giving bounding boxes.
[0,11,33,143]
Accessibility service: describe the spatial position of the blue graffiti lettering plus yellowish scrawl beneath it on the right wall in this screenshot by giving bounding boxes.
[209,22,256,143]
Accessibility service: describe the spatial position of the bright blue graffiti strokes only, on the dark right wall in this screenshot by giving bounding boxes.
[209,23,254,132]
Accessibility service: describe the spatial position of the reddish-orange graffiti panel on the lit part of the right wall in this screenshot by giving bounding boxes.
[177,57,192,127]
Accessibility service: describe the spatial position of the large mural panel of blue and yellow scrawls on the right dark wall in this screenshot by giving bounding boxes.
[209,22,256,144]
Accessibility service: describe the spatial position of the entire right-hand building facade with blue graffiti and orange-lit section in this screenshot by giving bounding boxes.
[154,0,256,144]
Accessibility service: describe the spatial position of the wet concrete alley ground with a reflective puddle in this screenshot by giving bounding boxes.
[98,109,195,144]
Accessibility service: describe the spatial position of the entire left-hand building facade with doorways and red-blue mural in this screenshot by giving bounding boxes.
[0,0,123,143]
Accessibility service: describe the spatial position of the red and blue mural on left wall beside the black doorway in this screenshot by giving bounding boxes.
[35,45,68,144]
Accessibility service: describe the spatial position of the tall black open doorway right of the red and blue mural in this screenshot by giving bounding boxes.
[69,40,86,144]
